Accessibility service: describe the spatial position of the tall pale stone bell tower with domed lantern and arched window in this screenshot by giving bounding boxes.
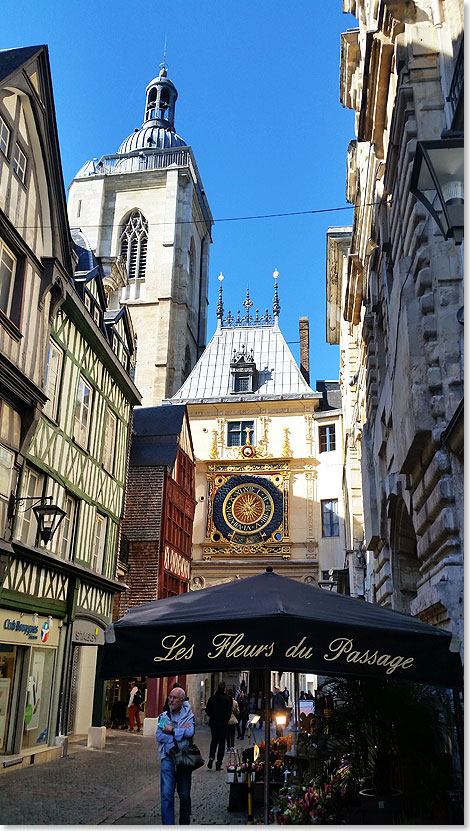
[68,64,213,407]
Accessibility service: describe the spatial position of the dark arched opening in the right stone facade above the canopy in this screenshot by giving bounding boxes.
[389,494,420,614]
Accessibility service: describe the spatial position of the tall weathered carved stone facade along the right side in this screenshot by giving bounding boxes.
[334,0,463,640]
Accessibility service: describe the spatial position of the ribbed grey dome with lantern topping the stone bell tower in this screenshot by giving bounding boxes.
[117,66,186,155]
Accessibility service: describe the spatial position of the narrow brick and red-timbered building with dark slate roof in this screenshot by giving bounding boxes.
[113,404,196,730]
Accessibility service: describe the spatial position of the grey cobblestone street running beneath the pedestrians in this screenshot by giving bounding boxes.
[0,726,264,826]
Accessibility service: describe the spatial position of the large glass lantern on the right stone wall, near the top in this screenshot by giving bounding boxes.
[410,137,464,245]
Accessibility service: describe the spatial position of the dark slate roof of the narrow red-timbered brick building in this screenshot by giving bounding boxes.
[130,404,186,468]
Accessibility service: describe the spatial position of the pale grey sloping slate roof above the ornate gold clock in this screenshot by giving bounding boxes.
[171,323,321,403]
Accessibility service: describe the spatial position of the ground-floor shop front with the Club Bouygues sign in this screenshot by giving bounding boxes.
[0,609,62,769]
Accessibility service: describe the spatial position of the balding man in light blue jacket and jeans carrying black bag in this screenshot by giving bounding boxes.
[155,687,194,825]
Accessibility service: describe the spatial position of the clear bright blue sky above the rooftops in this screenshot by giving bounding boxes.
[0,0,357,385]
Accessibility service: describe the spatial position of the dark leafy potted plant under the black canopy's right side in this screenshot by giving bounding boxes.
[328,678,450,824]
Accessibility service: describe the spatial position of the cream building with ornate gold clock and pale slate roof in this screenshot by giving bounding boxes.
[165,272,345,702]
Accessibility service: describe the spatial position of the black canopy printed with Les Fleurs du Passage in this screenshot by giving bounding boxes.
[101,566,462,687]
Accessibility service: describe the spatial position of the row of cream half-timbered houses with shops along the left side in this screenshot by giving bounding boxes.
[0,46,140,771]
